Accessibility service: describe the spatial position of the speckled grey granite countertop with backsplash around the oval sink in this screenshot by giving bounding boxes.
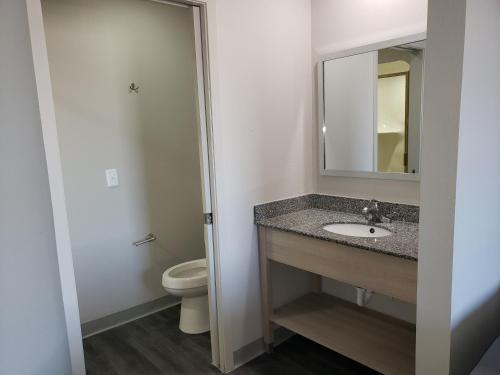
[255,194,419,260]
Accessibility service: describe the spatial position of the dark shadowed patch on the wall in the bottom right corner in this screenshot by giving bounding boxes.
[450,284,500,375]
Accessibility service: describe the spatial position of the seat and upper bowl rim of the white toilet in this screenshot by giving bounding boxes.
[162,259,208,289]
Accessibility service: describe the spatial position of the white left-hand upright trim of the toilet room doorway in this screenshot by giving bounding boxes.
[26,0,85,375]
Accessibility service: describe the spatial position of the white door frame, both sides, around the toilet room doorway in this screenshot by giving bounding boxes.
[26,0,225,375]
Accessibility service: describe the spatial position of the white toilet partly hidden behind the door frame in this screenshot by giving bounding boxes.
[162,259,210,334]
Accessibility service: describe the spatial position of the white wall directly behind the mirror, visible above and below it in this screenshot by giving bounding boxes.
[311,0,427,204]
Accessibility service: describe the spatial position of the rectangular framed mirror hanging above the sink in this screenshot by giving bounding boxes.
[318,37,425,180]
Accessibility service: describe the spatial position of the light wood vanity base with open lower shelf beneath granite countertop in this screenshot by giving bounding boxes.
[259,226,417,375]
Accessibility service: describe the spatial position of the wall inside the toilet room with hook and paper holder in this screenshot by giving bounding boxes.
[43,0,205,322]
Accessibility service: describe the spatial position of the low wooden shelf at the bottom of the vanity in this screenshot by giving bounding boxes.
[270,293,415,374]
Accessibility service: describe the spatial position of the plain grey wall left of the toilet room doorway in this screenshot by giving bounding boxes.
[0,0,71,375]
